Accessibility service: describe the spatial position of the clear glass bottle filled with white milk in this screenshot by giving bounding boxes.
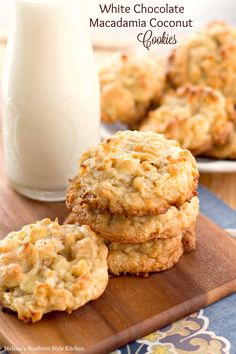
[2,0,100,201]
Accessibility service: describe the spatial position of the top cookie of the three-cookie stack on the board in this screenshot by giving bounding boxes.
[67,131,199,216]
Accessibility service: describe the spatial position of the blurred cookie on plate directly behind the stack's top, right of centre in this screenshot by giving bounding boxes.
[140,85,235,155]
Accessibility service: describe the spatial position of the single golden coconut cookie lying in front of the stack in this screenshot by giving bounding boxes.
[0,219,108,322]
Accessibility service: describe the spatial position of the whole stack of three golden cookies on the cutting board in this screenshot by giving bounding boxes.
[67,131,199,275]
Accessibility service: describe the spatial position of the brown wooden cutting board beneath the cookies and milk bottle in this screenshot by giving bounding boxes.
[0,143,236,354]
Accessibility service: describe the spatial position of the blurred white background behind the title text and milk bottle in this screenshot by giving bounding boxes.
[0,0,236,65]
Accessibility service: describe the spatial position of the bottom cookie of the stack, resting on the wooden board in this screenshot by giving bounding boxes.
[108,225,195,275]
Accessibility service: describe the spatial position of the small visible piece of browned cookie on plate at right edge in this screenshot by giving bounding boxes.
[204,127,236,160]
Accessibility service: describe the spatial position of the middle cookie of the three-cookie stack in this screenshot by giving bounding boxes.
[71,197,199,243]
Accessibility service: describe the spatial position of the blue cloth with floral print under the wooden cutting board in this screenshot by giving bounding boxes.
[114,186,236,354]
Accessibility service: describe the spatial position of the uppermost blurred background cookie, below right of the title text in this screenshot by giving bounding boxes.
[167,21,236,103]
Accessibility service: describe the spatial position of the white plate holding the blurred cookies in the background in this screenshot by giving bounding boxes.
[101,123,236,173]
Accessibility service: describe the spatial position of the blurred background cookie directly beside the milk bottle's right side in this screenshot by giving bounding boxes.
[100,54,165,126]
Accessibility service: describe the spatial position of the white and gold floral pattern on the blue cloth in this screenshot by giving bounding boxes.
[113,310,230,354]
